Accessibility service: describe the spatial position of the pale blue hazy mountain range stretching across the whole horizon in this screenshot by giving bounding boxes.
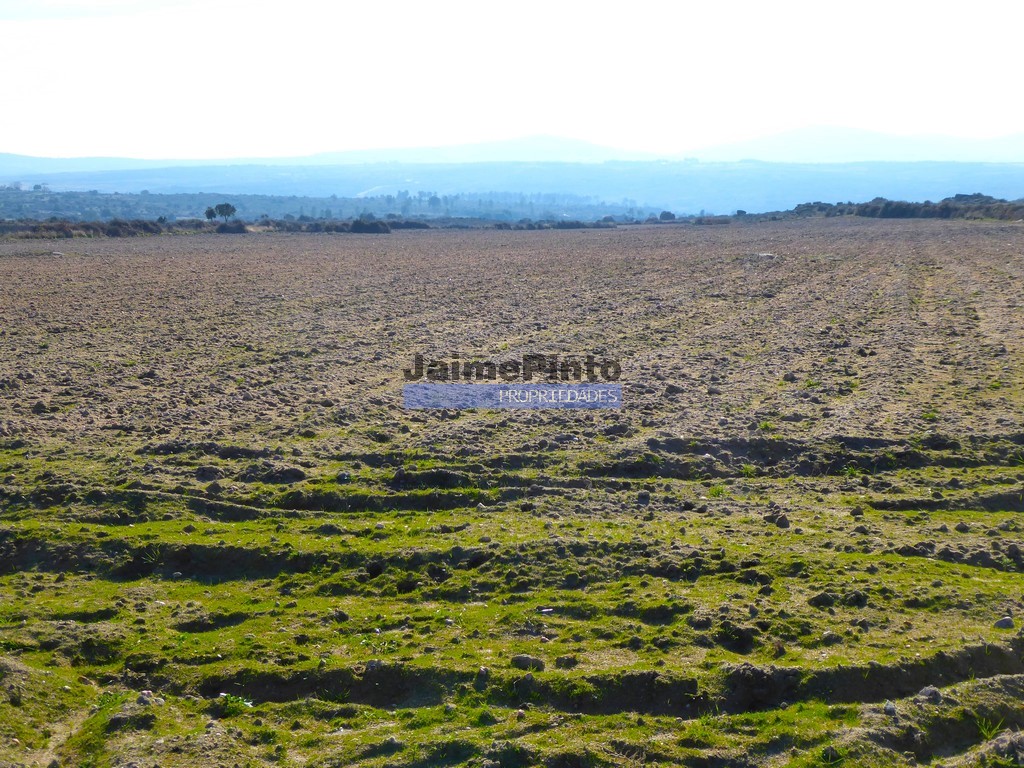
[0,128,1024,214]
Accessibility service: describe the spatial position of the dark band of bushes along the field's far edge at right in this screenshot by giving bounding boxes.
[787,194,1024,221]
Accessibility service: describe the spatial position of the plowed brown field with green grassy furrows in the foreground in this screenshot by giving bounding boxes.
[0,219,1024,768]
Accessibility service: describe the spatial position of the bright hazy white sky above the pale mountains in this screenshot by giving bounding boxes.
[0,0,1024,158]
